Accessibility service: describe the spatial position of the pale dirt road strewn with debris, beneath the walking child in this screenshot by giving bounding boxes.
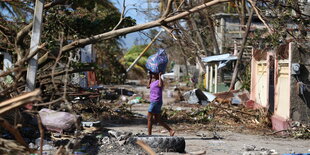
[100,84,310,155]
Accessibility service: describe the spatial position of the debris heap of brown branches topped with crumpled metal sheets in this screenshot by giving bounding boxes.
[162,89,271,130]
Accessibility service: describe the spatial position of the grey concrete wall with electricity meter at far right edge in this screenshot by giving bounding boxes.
[290,43,310,124]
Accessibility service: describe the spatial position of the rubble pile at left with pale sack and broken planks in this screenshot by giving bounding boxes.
[0,88,142,154]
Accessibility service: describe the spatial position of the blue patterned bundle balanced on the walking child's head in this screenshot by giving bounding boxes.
[146,49,168,74]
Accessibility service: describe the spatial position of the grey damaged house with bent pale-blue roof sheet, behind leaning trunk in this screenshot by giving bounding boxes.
[202,13,272,93]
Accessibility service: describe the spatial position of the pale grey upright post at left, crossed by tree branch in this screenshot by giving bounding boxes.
[26,0,44,91]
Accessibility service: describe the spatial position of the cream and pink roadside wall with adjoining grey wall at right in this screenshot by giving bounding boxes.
[250,42,310,130]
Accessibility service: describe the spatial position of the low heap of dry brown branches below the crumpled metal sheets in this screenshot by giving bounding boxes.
[163,102,271,129]
